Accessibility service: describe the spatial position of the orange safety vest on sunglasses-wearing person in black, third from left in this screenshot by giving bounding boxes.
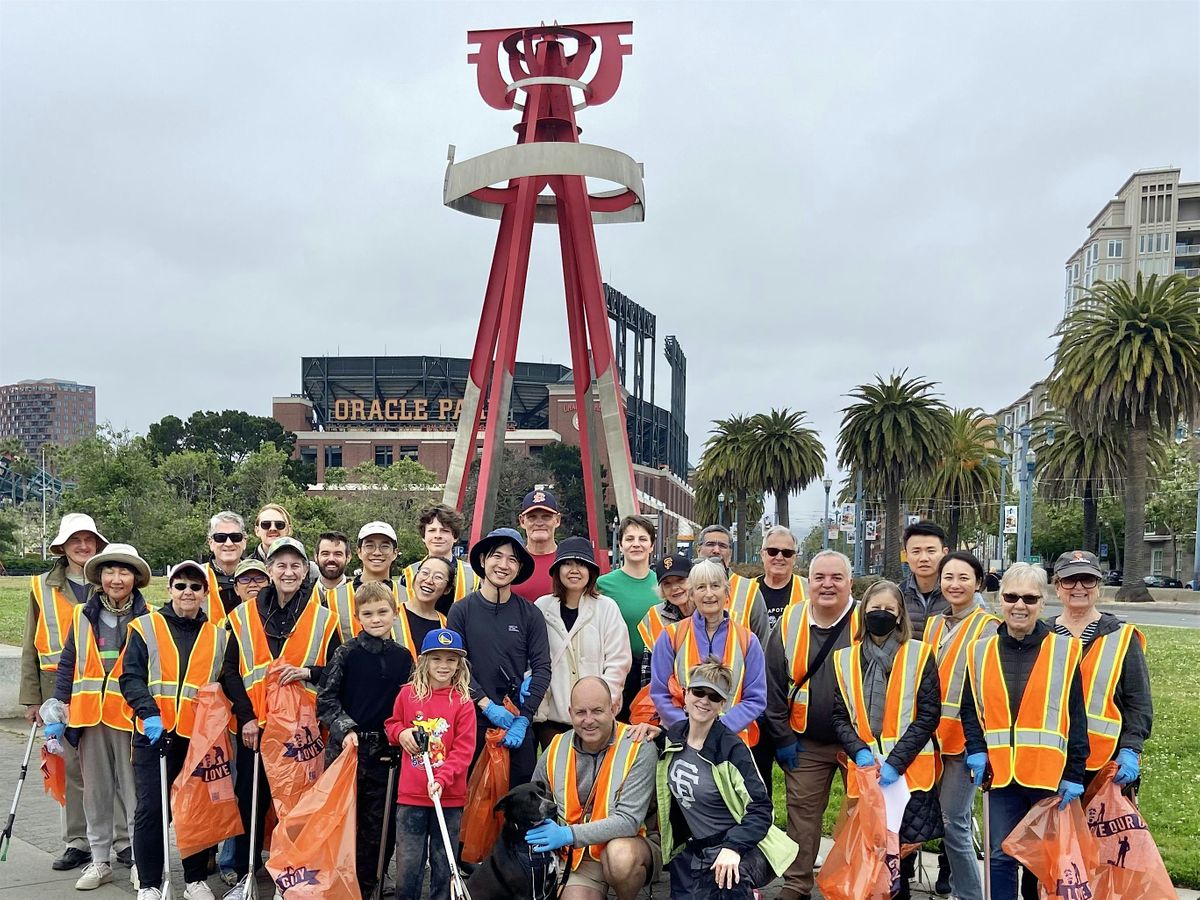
[130,610,229,738]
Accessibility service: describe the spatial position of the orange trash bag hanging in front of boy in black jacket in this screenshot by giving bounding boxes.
[266,746,359,900]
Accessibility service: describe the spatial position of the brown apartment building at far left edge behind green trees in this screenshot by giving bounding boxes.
[0,378,96,457]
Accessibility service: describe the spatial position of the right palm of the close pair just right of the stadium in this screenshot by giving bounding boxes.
[749,408,824,526]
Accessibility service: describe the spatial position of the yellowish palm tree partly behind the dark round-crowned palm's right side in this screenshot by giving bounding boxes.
[920,407,1004,550]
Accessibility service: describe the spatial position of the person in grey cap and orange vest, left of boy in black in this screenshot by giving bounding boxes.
[221,538,341,898]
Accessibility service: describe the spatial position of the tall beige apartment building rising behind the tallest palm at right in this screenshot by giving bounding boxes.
[1063,168,1200,312]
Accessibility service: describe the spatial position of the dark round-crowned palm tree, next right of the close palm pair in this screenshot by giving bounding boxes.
[838,370,950,581]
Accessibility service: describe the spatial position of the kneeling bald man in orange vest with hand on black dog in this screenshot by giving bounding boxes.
[528,676,662,900]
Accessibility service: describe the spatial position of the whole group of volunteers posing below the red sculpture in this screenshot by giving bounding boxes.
[20,490,1152,900]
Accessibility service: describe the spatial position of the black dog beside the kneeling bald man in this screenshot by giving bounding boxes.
[467,784,558,900]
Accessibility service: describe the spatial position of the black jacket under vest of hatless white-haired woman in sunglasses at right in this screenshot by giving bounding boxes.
[959,620,1088,784]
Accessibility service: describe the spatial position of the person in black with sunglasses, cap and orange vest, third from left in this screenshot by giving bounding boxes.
[121,559,228,900]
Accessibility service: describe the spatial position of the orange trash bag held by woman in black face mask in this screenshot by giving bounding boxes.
[817,766,900,900]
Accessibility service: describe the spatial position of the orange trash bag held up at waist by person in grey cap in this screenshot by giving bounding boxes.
[259,660,325,818]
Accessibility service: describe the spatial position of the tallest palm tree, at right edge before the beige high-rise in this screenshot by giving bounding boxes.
[1050,272,1200,593]
